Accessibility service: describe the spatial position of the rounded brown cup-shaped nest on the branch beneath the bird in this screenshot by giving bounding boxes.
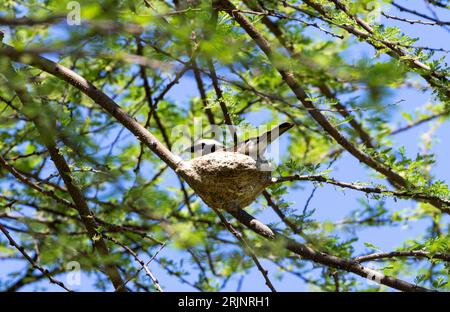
[178,152,271,210]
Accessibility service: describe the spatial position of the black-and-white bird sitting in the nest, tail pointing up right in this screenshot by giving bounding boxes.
[187,122,294,160]
